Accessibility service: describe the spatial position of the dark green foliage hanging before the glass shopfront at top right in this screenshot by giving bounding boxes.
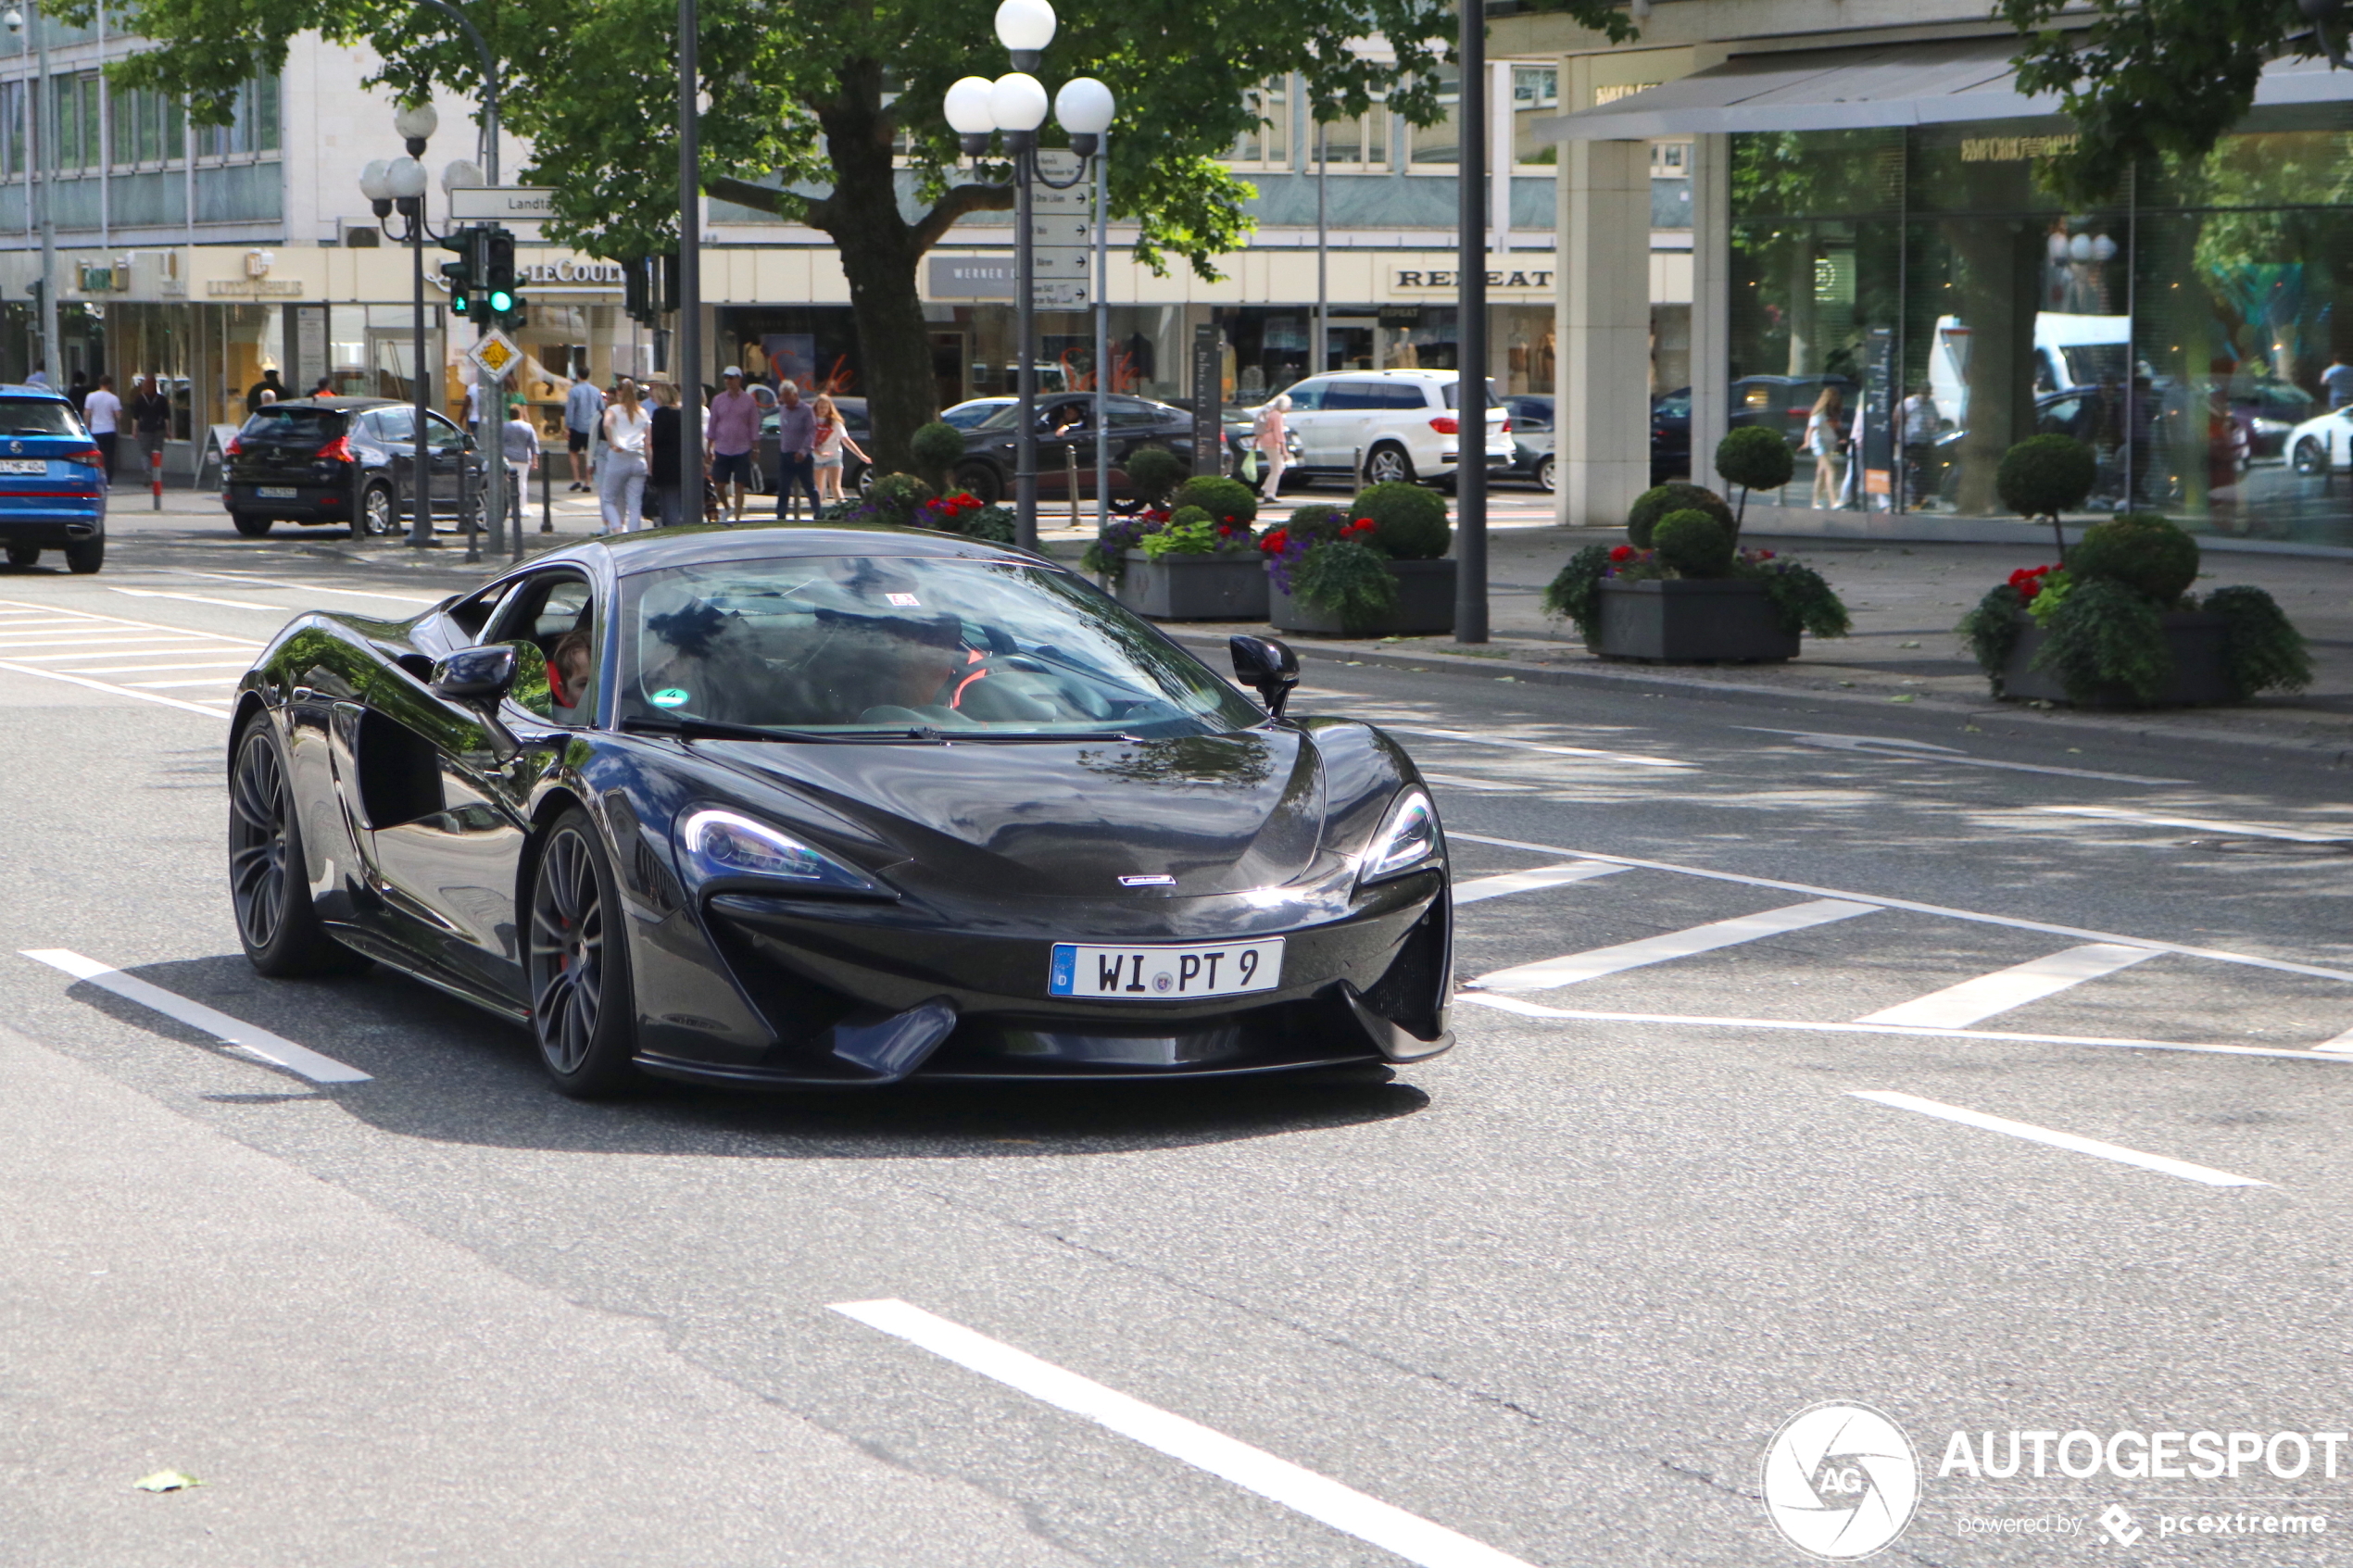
[1995,0,2344,207]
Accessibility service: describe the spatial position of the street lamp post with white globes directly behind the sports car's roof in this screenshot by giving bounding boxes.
[941,0,1113,550]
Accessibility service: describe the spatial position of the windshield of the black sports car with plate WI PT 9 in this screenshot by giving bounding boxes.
[616,555,1264,741]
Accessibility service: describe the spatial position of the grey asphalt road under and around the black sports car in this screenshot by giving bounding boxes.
[0,538,2353,1568]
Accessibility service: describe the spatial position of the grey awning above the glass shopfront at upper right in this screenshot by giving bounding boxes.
[1534,35,2353,141]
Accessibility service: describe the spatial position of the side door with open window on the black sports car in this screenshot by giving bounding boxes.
[360,567,598,997]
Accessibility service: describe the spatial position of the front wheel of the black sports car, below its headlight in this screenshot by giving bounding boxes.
[524,807,640,1100]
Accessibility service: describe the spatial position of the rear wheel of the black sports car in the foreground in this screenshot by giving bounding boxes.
[228,715,367,980]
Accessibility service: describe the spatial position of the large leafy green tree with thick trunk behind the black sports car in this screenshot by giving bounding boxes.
[96,0,1630,468]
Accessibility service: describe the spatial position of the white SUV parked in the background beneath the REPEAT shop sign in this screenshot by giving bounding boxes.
[1285,370,1513,486]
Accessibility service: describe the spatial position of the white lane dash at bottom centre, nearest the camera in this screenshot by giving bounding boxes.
[833,1300,1529,1568]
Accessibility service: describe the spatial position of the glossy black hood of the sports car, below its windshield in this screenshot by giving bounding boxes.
[698,726,1325,898]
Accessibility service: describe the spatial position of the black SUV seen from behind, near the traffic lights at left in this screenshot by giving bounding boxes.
[221,397,483,538]
